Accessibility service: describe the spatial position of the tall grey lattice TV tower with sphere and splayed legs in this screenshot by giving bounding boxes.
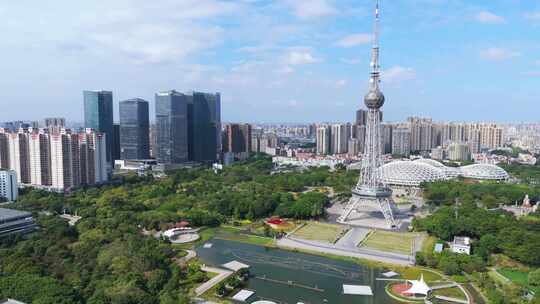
[338,0,396,228]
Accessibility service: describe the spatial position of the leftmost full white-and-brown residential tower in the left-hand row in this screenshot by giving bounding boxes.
[9,129,31,184]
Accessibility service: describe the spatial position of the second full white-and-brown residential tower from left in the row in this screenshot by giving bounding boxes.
[28,129,51,186]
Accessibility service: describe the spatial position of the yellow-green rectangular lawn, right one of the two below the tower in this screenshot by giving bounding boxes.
[360,230,417,254]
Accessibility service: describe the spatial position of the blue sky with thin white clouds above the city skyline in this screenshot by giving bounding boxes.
[0,0,540,122]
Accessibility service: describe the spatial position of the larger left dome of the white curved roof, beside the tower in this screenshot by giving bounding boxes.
[379,161,447,187]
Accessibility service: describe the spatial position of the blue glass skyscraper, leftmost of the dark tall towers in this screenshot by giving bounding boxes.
[83,91,116,164]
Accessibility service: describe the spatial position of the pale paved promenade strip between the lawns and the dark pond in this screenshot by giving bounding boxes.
[277,238,414,266]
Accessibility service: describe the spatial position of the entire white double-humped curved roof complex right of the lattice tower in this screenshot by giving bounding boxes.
[379,158,509,187]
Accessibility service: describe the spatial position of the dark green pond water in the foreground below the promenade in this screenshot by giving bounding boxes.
[196,239,399,304]
